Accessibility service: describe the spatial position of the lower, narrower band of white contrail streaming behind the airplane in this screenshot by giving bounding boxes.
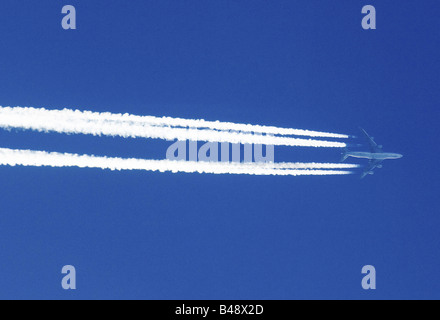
[0,148,351,176]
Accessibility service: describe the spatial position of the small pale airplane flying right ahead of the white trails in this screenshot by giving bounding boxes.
[341,128,403,179]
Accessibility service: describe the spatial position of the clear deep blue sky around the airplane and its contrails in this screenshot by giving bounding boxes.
[0,0,440,299]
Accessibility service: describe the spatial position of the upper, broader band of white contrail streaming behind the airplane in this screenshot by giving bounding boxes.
[0,107,346,148]
